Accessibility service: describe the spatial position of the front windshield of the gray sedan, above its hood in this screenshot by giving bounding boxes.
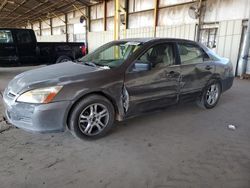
[78,41,141,68]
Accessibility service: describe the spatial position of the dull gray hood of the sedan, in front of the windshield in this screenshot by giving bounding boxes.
[8,62,103,94]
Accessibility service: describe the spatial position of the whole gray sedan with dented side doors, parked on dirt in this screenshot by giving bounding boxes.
[4,38,234,139]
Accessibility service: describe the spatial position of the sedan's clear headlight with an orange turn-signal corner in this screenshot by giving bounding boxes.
[17,86,62,104]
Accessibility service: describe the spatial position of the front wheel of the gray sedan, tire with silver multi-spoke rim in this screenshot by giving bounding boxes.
[69,95,115,139]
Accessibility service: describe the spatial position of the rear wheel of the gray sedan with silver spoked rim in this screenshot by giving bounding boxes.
[196,80,221,109]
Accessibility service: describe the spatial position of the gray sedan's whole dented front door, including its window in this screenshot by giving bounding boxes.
[124,42,180,116]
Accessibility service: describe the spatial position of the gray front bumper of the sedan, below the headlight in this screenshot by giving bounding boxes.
[3,90,71,132]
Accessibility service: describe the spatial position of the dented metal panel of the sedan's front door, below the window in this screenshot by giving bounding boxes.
[125,66,180,115]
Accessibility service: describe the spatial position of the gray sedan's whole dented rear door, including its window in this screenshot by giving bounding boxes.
[178,42,215,101]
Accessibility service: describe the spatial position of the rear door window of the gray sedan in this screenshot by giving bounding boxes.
[178,44,209,65]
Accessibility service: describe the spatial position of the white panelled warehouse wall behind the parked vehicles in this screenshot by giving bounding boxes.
[29,0,250,74]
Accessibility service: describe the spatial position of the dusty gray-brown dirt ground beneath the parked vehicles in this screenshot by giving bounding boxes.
[0,67,250,188]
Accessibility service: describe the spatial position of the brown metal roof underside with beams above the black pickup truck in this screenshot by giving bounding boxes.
[0,0,102,27]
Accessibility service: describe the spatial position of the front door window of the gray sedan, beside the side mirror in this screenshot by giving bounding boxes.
[133,43,175,72]
